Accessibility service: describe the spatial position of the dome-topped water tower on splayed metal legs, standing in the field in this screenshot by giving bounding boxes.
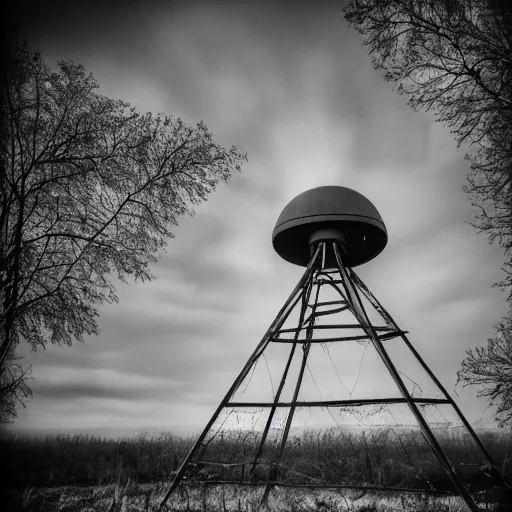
[161,186,503,512]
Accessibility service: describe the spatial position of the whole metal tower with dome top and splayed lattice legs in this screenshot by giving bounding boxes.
[161,186,506,512]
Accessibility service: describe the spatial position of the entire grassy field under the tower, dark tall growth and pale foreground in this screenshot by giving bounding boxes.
[3,432,512,512]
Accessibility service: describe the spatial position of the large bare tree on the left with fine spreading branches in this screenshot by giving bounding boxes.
[0,42,246,420]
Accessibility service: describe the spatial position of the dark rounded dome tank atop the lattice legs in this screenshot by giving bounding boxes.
[272,186,388,267]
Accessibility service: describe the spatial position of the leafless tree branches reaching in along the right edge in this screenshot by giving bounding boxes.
[344,0,512,424]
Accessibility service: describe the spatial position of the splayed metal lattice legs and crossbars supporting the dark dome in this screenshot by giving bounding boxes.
[161,241,499,512]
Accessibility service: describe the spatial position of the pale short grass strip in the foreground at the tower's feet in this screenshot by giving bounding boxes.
[7,482,496,512]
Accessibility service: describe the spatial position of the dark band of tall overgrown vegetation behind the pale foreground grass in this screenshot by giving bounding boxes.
[4,429,512,490]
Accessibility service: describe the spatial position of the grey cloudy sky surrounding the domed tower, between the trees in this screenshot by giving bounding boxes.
[8,1,506,436]
